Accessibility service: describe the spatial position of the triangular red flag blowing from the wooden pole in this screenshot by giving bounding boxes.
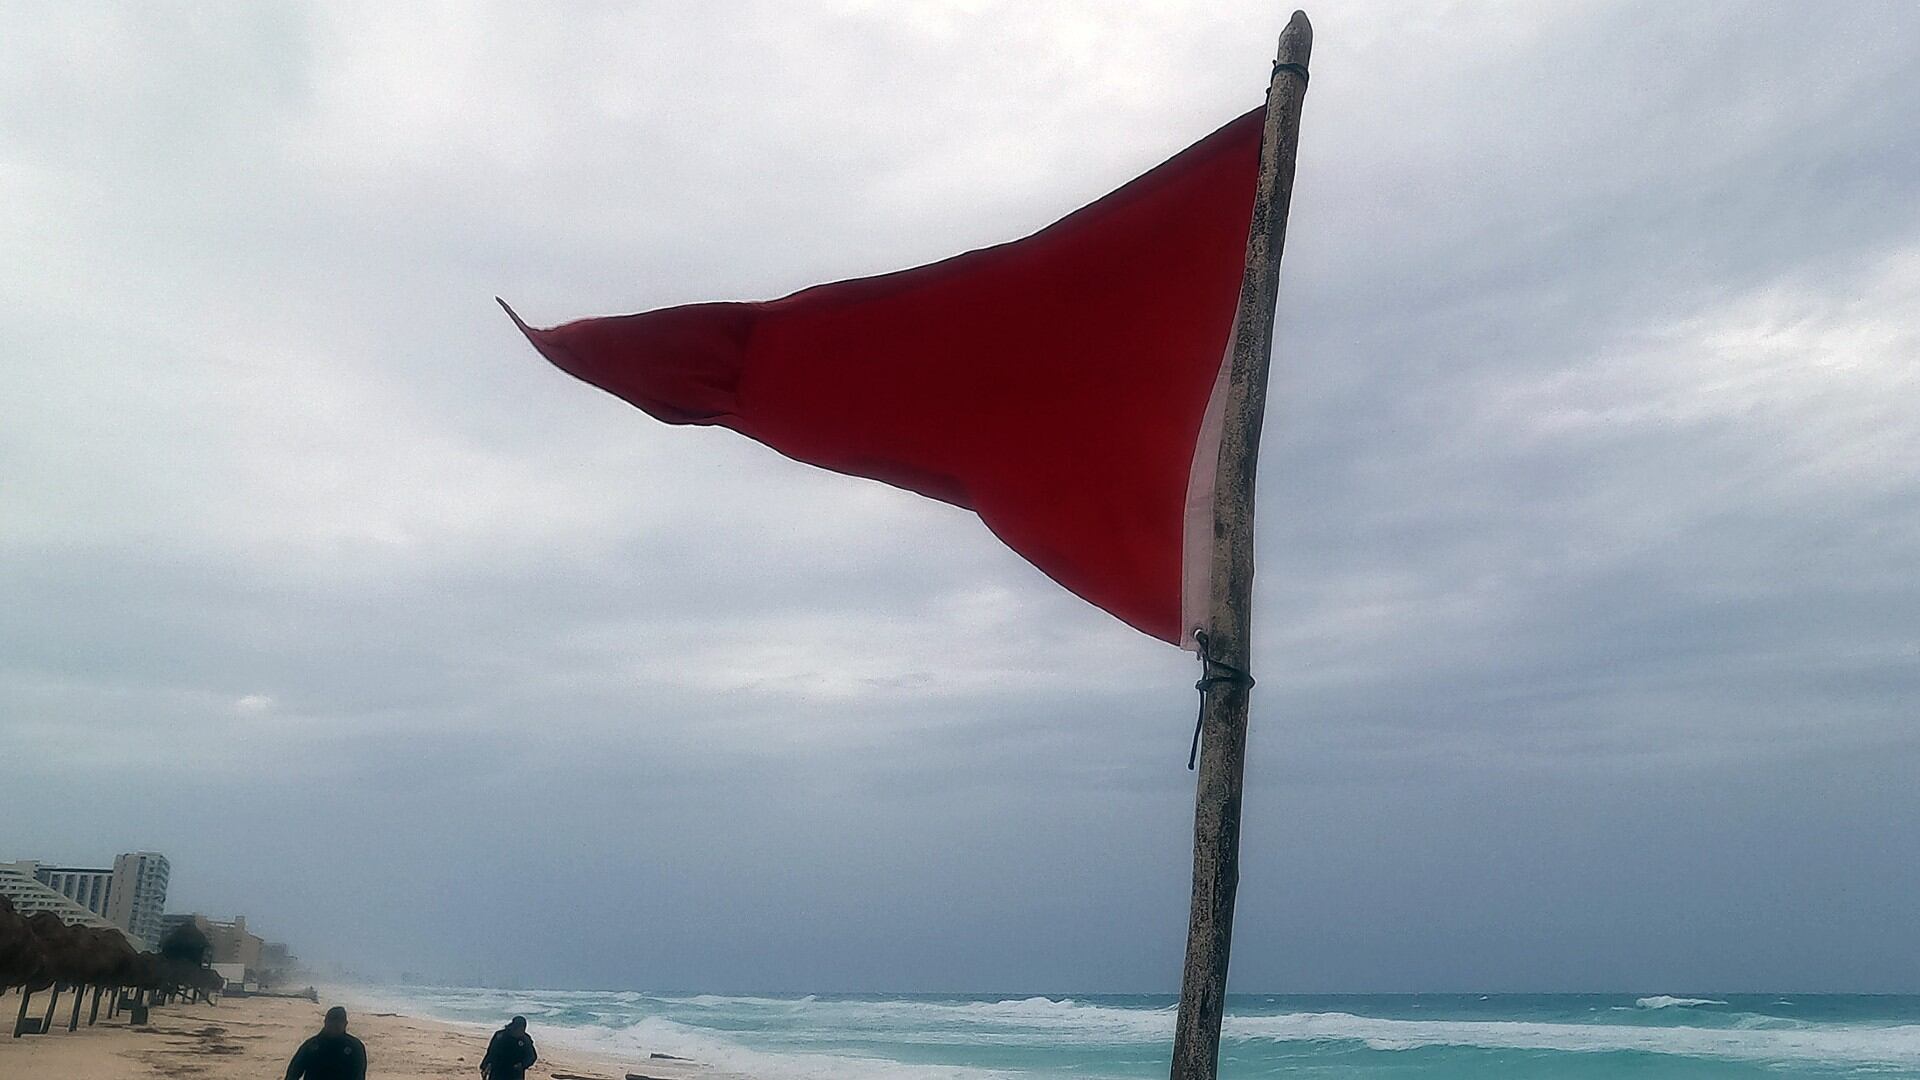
[503,110,1265,648]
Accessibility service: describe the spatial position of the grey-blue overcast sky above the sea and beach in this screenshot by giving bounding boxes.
[0,0,1920,992]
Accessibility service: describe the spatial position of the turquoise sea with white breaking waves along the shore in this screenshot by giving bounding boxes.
[353,988,1920,1080]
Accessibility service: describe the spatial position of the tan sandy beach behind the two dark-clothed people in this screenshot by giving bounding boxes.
[0,994,720,1080]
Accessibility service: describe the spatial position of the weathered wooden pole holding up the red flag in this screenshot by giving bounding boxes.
[1173,12,1313,1080]
